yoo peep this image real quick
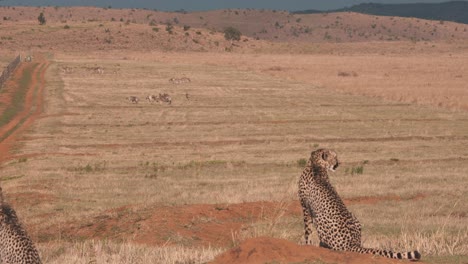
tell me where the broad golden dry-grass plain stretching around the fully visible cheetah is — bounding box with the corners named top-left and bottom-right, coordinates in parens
top-left (1, 48), bottom-right (468, 263)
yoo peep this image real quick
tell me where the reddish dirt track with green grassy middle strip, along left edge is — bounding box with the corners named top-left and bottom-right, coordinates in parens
top-left (0, 55), bottom-right (49, 164)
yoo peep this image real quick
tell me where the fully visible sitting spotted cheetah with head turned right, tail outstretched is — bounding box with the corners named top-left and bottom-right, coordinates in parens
top-left (299, 149), bottom-right (421, 260)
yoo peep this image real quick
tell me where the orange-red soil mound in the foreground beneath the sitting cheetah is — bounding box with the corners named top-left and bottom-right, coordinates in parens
top-left (211, 237), bottom-right (422, 264)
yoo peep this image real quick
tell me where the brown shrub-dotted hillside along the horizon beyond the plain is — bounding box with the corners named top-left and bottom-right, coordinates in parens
top-left (0, 7), bottom-right (468, 43)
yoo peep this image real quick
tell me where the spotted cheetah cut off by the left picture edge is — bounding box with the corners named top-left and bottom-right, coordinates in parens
top-left (0, 188), bottom-right (41, 264)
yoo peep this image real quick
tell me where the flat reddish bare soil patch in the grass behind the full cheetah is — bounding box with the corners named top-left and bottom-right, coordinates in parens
top-left (49, 194), bottom-right (426, 247)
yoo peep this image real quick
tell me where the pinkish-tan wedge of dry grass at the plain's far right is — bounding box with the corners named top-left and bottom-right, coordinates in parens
top-left (123, 47), bottom-right (468, 110)
